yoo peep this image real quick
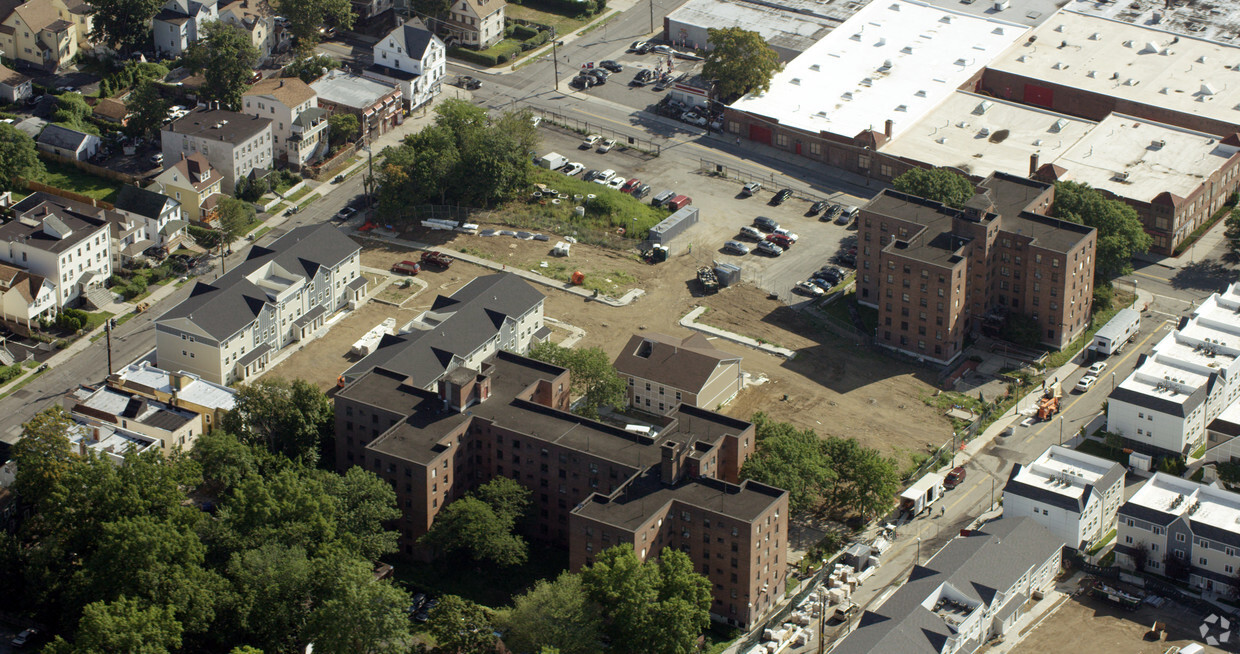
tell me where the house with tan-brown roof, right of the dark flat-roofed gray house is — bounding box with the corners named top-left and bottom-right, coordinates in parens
top-left (241, 77), bottom-right (327, 168)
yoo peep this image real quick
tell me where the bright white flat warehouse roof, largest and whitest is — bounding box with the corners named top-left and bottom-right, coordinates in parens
top-left (733, 0), bottom-right (1029, 138)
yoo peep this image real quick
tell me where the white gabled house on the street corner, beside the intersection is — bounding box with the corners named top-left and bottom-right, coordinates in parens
top-left (363, 19), bottom-right (448, 109)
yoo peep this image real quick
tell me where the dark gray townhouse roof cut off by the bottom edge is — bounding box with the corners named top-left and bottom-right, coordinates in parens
top-left (833, 517), bottom-right (1064, 654)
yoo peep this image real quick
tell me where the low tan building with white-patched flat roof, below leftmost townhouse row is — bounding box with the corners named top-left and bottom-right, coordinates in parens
top-left (107, 361), bottom-right (237, 432)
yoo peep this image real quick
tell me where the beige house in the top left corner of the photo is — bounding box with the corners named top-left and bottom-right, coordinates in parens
top-left (0, 0), bottom-right (78, 72)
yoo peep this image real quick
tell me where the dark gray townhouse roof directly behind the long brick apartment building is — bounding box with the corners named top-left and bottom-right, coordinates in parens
top-left (345, 273), bottom-right (543, 388)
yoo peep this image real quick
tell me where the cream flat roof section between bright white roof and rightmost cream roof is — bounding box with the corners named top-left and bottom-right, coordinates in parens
top-left (882, 91), bottom-right (1096, 177)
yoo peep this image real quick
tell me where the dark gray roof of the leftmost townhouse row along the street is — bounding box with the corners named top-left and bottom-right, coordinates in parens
top-left (159, 223), bottom-right (361, 340)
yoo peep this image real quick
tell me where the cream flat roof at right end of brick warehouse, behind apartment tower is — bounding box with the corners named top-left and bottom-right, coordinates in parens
top-left (1054, 114), bottom-right (1240, 202)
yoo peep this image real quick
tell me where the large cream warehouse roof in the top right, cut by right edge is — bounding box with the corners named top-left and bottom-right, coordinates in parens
top-left (988, 11), bottom-right (1240, 132)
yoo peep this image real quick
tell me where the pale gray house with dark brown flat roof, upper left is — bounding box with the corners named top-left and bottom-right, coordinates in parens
top-left (160, 109), bottom-right (274, 195)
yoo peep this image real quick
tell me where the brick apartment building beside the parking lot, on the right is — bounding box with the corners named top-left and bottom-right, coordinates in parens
top-left (857, 172), bottom-right (1097, 362)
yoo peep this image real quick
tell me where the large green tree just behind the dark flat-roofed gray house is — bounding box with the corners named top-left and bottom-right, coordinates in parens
top-left (185, 21), bottom-right (257, 109)
